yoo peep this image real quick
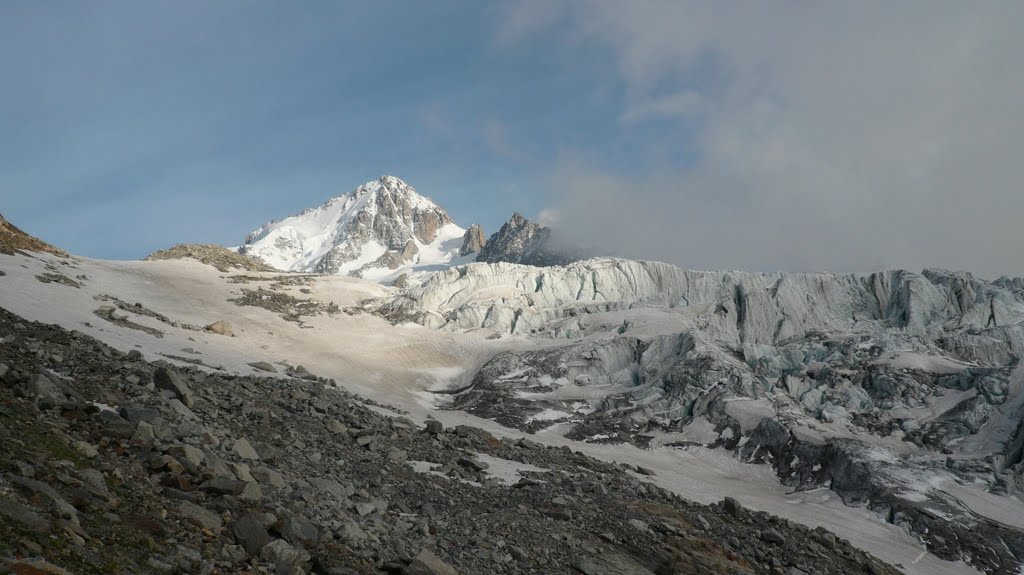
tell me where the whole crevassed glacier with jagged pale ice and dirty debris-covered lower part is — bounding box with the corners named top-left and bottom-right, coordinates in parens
top-left (370, 259), bottom-right (1024, 573)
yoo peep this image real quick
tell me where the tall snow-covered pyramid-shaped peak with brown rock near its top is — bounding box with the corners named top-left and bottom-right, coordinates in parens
top-left (239, 176), bottom-right (465, 279)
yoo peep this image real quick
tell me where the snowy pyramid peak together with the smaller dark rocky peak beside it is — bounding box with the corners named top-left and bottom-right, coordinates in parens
top-left (232, 176), bottom-right (595, 283)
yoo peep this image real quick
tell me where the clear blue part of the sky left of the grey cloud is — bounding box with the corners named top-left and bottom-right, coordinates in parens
top-left (0, 2), bottom-right (656, 258)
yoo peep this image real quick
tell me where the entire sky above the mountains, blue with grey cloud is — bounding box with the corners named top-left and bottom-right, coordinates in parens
top-left (0, 0), bottom-right (1024, 277)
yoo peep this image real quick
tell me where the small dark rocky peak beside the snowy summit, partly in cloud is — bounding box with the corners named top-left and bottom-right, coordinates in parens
top-left (476, 212), bottom-right (589, 266)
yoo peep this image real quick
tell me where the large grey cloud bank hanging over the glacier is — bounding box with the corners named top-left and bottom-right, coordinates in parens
top-left (504, 1), bottom-right (1024, 275)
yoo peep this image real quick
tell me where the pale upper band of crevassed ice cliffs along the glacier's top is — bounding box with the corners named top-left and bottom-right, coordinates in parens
top-left (379, 258), bottom-right (1024, 349)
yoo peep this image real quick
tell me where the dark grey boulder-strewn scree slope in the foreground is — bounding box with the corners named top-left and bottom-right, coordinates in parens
top-left (0, 309), bottom-right (897, 575)
